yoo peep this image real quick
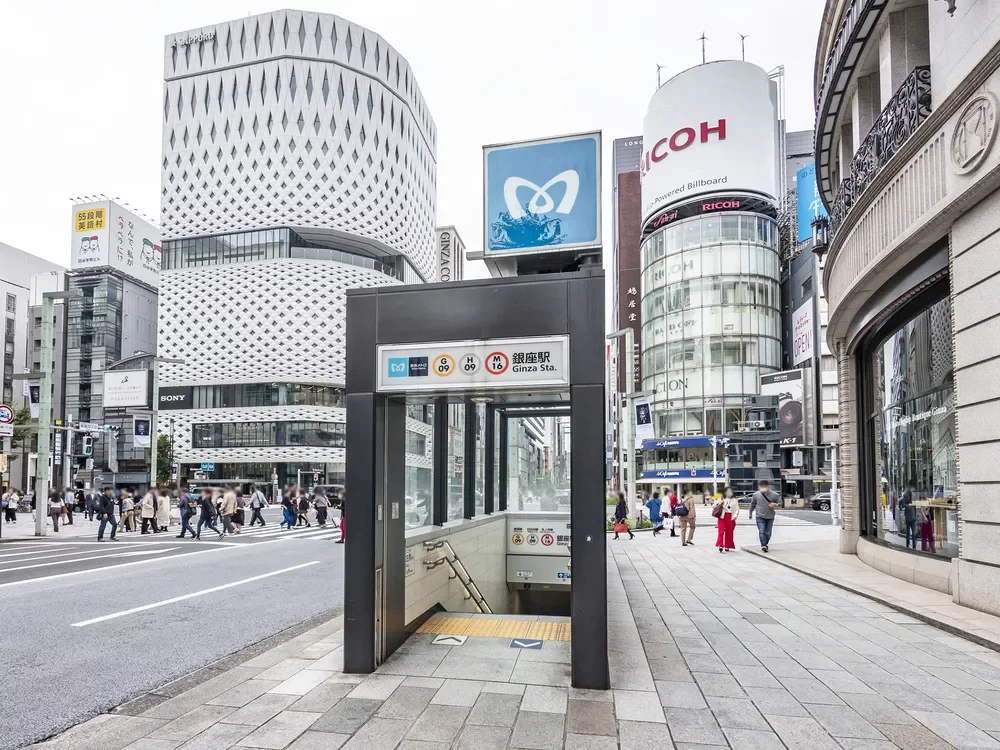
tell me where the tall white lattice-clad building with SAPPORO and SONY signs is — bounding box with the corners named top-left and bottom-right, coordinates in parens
top-left (159, 10), bottom-right (437, 494)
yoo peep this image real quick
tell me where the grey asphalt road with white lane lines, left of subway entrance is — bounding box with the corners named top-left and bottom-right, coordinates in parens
top-left (0, 511), bottom-right (344, 750)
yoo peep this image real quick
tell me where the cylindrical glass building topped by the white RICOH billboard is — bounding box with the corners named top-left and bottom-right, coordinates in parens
top-left (641, 61), bottom-right (781, 490)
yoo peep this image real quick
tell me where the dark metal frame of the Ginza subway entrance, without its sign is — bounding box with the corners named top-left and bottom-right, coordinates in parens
top-left (344, 268), bottom-right (610, 690)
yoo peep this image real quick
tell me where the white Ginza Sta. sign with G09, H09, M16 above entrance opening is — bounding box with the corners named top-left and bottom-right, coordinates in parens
top-left (376, 336), bottom-right (569, 393)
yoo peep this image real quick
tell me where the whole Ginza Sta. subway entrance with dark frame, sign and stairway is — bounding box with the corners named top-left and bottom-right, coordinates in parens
top-left (344, 269), bottom-right (610, 689)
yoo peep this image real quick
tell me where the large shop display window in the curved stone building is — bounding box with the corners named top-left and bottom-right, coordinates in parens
top-left (859, 288), bottom-right (958, 557)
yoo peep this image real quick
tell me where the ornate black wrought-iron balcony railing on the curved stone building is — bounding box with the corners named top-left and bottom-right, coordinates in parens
top-left (830, 65), bottom-right (931, 237)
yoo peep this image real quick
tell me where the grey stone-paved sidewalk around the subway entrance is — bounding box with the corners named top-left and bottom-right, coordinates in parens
top-left (31, 535), bottom-right (1000, 750)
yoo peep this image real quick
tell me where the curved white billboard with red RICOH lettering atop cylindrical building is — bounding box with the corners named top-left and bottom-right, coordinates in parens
top-left (640, 60), bottom-right (778, 222)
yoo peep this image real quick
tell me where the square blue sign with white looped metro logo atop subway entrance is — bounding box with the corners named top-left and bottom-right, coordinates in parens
top-left (483, 131), bottom-right (601, 257)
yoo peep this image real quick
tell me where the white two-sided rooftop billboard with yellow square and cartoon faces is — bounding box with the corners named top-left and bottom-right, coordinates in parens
top-left (70, 201), bottom-right (160, 289)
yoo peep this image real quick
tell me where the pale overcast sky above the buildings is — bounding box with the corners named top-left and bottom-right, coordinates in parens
top-left (0, 0), bottom-right (823, 274)
